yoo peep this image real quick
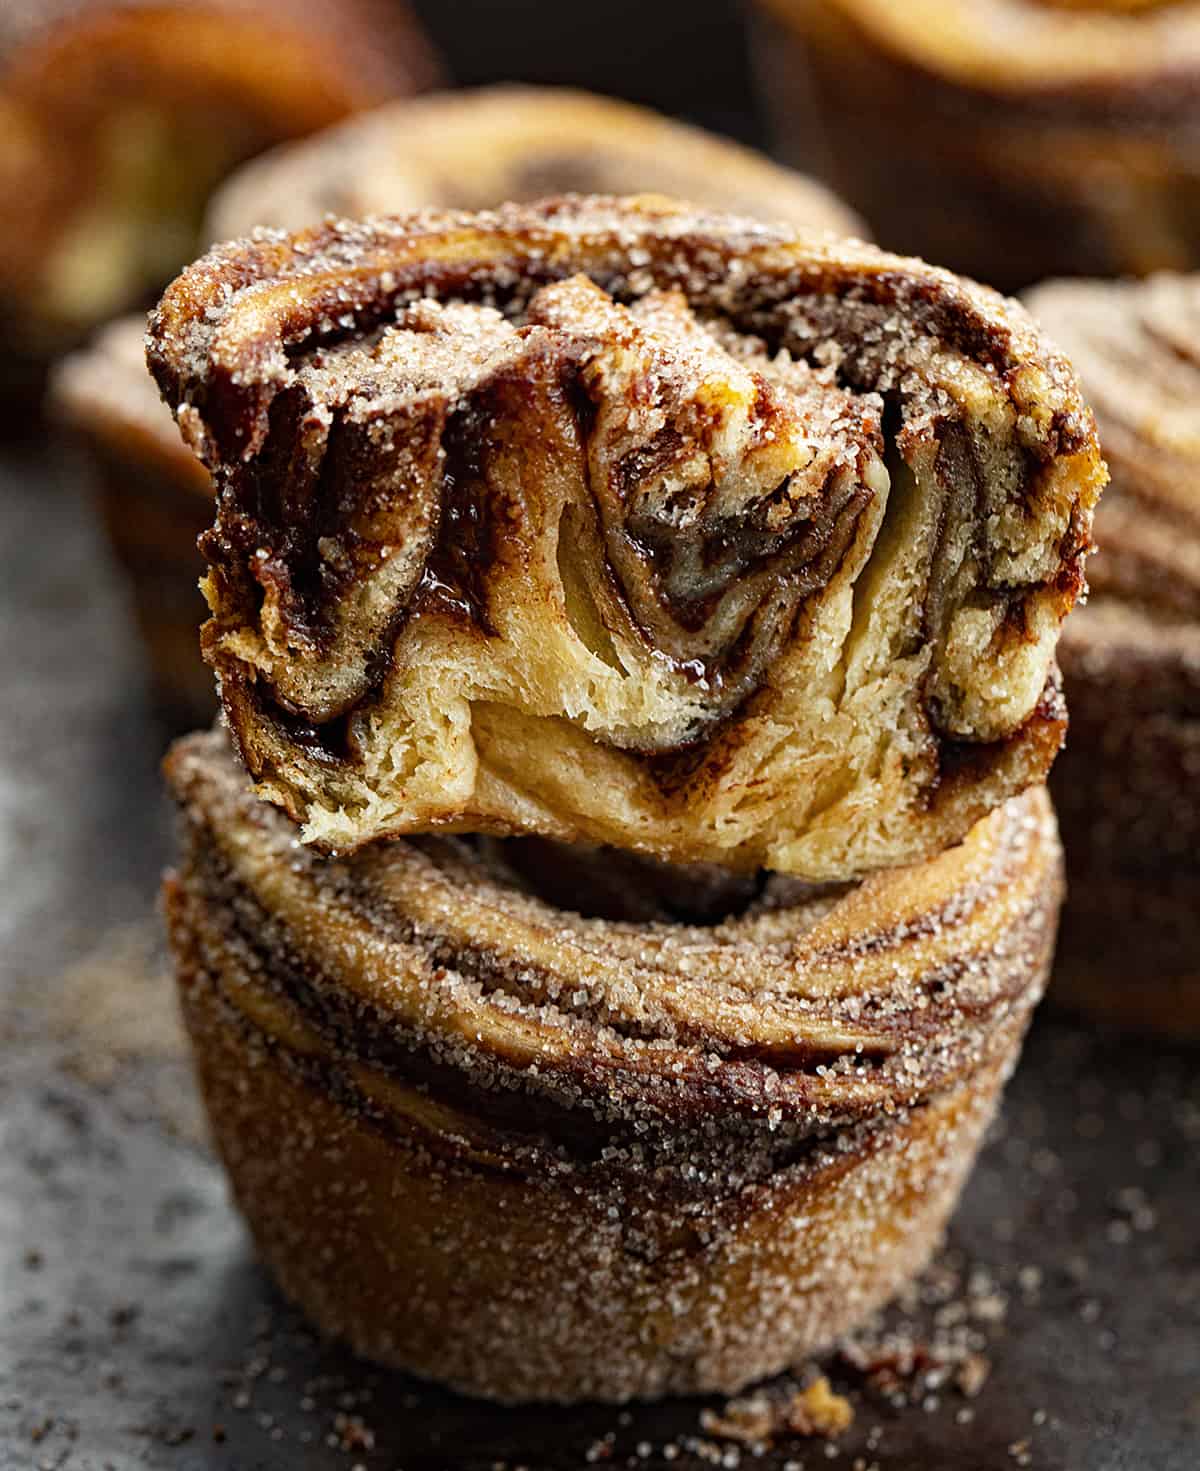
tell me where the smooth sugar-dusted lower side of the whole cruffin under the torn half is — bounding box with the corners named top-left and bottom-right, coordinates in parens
top-left (168, 890), bottom-right (1019, 1403)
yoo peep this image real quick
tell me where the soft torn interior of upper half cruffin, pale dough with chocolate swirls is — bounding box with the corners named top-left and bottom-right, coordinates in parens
top-left (198, 278), bottom-right (1066, 874)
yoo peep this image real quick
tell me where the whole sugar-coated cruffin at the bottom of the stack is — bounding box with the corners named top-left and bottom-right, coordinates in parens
top-left (166, 734), bottom-right (1060, 1400)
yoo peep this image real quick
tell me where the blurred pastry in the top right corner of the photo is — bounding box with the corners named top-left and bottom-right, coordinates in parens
top-left (756, 0), bottom-right (1200, 290)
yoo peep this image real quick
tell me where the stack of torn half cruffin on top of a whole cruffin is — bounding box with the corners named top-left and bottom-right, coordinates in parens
top-left (149, 197), bottom-right (1104, 1400)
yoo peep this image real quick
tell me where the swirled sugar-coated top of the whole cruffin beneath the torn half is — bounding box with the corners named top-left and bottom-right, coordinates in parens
top-left (166, 731), bottom-right (1060, 1169)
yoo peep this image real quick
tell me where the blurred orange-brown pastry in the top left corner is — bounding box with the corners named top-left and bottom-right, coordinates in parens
top-left (0, 0), bottom-right (435, 380)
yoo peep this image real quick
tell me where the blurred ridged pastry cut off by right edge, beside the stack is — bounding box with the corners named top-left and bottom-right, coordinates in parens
top-left (1028, 275), bottom-right (1200, 1039)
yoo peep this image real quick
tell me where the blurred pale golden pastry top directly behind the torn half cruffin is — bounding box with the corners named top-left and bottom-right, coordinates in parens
top-left (207, 85), bottom-right (866, 240)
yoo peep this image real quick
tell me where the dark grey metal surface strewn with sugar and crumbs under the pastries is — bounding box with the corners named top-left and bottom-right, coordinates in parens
top-left (0, 455), bottom-right (1200, 1471)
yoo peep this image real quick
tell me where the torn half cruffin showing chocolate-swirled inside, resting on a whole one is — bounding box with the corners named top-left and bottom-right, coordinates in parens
top-left (150, 199), bottom-right (1103, 880)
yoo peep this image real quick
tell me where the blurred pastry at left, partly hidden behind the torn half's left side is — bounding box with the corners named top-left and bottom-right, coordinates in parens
top-left (50, 313), bottom-right (215, 730)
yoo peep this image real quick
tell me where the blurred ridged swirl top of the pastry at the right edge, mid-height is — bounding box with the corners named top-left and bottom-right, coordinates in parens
top-left (1028, 275), bottom-right (1200, 634)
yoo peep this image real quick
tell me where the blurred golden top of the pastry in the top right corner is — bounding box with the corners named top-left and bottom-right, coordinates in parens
top-left (760, 0), bottom-right (1200, 89)
